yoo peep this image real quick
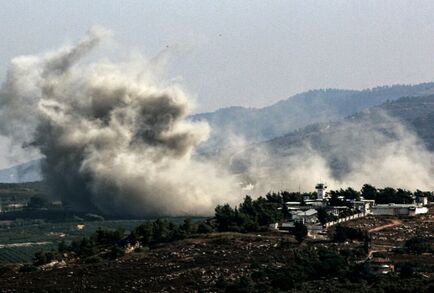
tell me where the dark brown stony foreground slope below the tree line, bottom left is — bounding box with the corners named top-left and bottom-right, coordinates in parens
top-left (0, 234), bottom-right (304, 292)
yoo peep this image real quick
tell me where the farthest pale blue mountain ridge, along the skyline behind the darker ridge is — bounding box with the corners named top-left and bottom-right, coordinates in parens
top-left (191, 83), bottom-right (434, 152)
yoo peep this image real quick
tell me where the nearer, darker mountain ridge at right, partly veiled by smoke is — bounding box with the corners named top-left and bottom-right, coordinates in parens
top-left (231, 95), bottom-right (434, 178)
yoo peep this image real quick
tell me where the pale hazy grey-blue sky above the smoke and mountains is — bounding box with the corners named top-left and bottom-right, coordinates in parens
top-left (0, 0), bottom-right (434, 111)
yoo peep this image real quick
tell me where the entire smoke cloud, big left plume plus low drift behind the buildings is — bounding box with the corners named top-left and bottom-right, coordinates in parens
top-left (0, 28), bottom-right (434, 216)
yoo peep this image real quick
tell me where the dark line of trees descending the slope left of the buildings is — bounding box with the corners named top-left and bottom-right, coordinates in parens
top-left (34, 193), bottom-right (307, 265)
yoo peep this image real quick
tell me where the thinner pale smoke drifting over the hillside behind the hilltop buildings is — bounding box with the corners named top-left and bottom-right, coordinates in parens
top-left (232, 111), bottom-right (434, 194)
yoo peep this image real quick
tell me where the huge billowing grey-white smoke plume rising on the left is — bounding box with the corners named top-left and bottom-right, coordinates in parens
top-left (0, 29), bottom-right (240, 216)
